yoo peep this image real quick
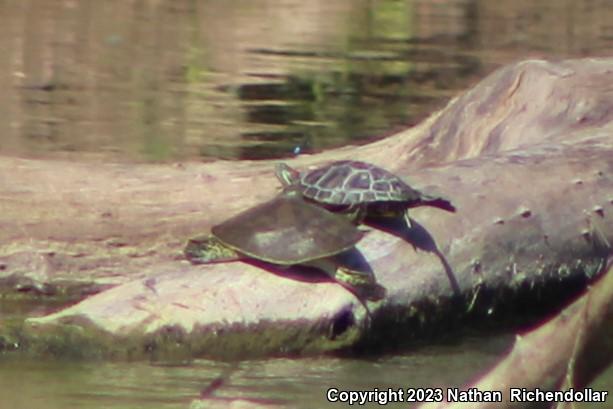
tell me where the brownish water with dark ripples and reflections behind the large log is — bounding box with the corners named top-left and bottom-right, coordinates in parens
top-left (0, 0), bottom-right (613, 160)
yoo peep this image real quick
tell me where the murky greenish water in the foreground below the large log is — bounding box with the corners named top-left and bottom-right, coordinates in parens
top-left (0, 337), bottom-right (511, 409)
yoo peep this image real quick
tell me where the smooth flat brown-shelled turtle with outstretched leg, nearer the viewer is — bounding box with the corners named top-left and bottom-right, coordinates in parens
top-left (183, 189), bottom-right (385, 300)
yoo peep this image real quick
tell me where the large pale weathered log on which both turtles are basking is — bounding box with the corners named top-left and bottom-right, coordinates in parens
top-left (0, 59), bottom-right (613, 357)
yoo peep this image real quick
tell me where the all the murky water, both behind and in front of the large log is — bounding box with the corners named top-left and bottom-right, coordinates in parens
top-left (0, 0), bottom-right (613, 408)
